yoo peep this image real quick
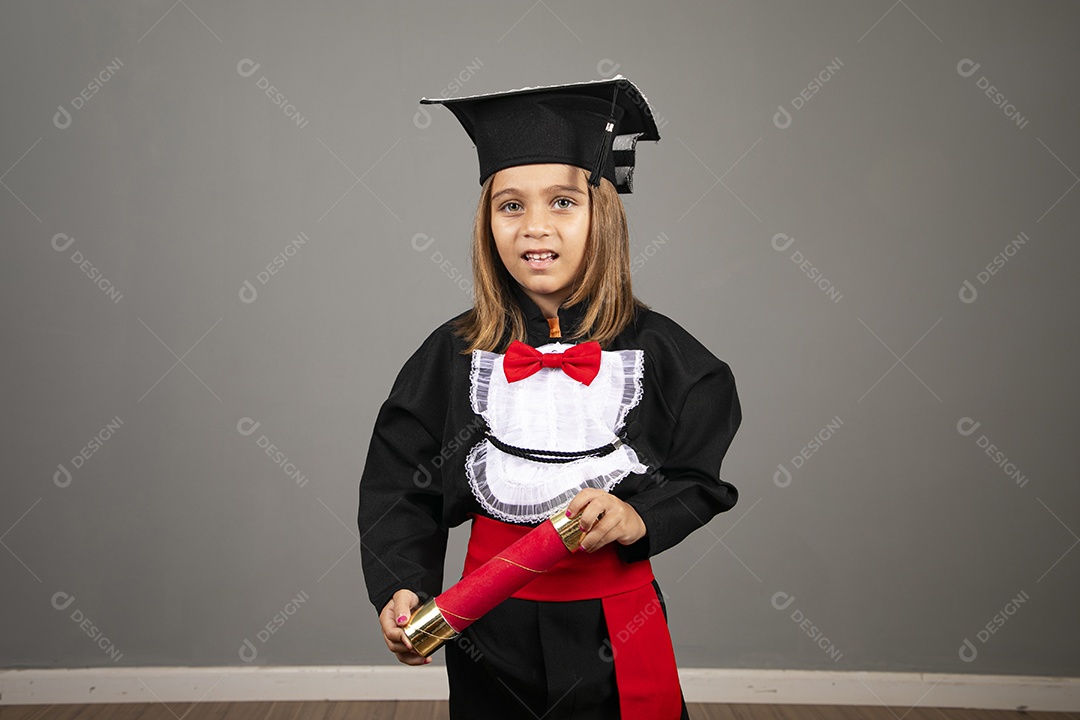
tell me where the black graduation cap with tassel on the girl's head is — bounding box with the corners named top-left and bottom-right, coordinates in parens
top-left (420, 74), bottom-right (660, 192)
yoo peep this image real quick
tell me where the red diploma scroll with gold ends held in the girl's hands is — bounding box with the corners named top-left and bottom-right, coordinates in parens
top-left (404, 505), bottom-right (584, 657)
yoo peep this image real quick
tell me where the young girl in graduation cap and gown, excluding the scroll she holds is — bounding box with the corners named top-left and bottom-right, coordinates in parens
top-left (359, 76), bottom-right (741, 720)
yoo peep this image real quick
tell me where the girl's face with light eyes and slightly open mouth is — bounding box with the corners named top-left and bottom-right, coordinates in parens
top-left (490, 164), bottom-right (591, 317)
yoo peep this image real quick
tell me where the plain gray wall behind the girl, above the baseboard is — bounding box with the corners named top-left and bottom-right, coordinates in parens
top-left (0, 0), bottom-right (1080, 676)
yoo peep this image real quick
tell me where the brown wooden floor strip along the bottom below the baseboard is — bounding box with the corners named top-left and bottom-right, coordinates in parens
top-left (0, 702), bottom-right (1080, 720)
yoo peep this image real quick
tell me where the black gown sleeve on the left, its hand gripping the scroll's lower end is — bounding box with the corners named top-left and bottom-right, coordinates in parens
top-left (357, 326), bottom-right (454, 611)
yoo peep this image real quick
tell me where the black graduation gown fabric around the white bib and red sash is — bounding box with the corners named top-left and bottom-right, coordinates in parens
top-left (357, 287), bottom-right (742, 718)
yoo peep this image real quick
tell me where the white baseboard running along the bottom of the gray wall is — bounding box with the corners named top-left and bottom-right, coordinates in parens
top-left (0, 664), bottom-right (1080, 712)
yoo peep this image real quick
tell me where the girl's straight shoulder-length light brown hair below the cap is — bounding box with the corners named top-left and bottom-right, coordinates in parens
top-left (455, 166), bottom-right (647, 354)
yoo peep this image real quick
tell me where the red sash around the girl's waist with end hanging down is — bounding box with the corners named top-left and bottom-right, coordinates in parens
top-left (461, 513), bottom-right (683, 720)
